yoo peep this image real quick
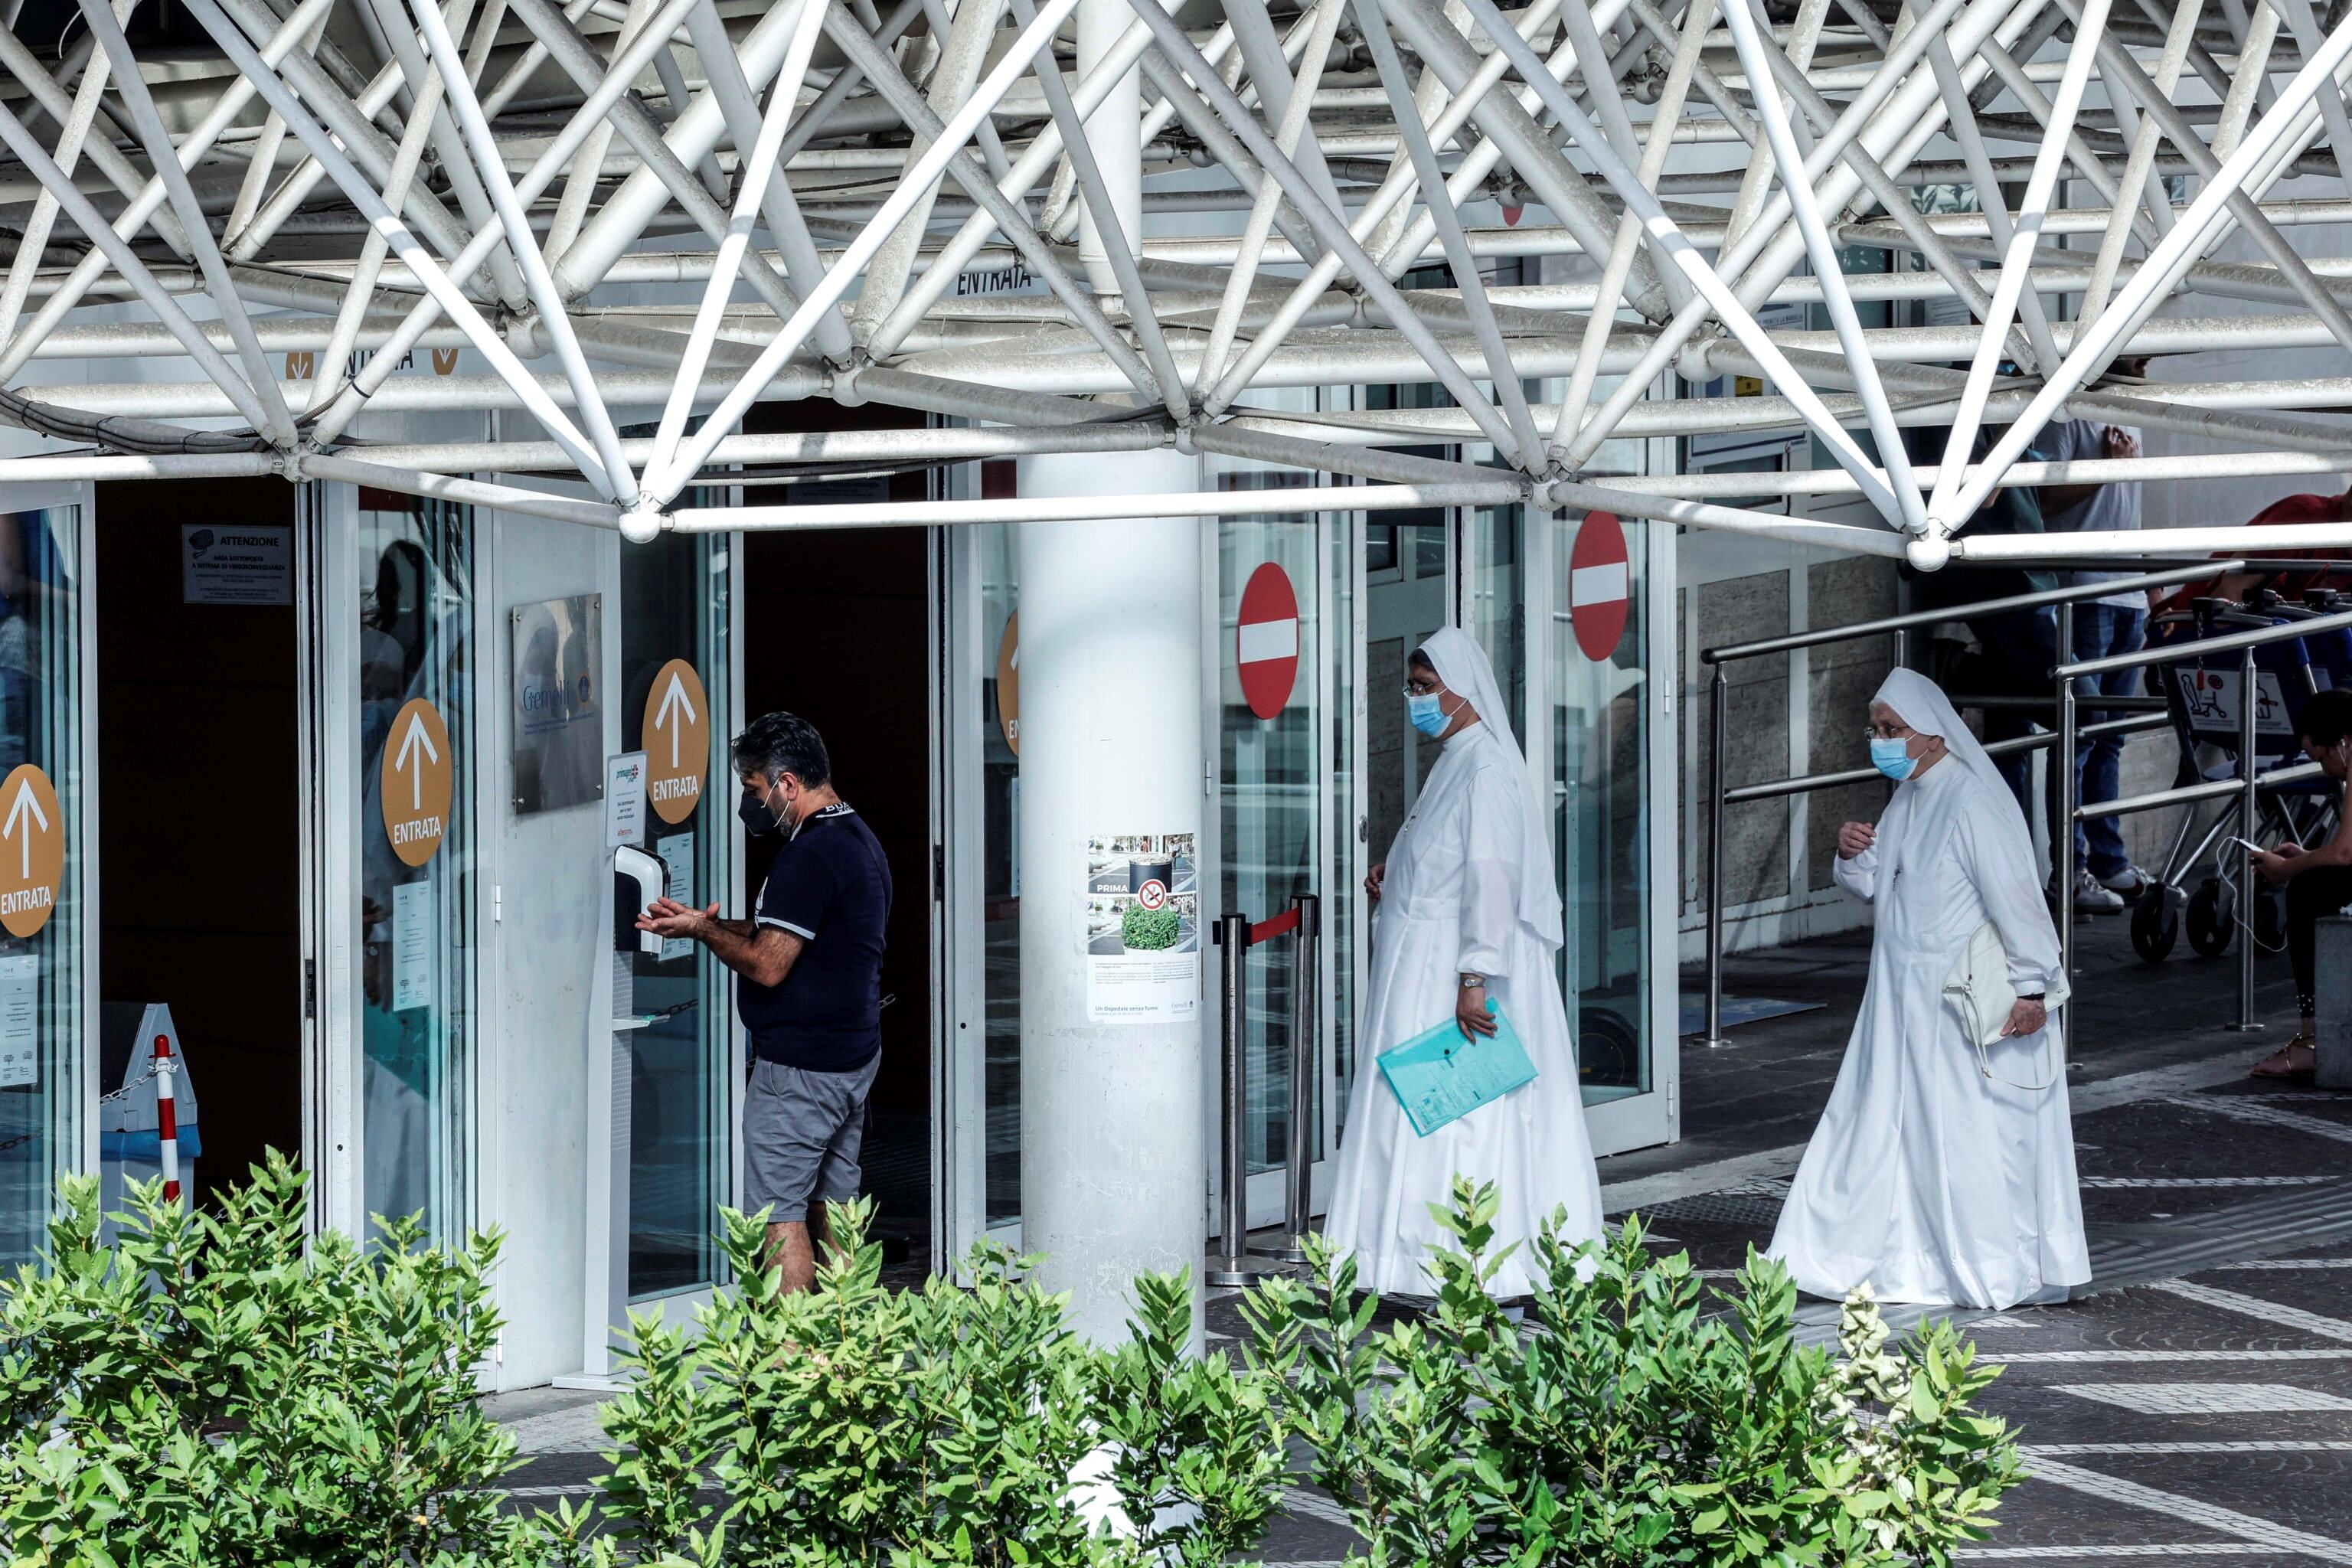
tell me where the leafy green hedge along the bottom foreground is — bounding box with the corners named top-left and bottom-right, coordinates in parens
top-left (0, 1159), bottom-right (2018, 1568)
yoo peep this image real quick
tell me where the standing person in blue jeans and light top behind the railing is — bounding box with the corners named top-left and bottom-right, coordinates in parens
top-left (2034, 355), bottom-right (2150, 914)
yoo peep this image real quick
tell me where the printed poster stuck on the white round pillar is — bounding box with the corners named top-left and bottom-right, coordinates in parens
top-left (1084, 832), bottom-right (1200, 1023)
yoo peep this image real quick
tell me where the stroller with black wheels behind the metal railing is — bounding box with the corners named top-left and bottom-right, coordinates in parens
top-left (2131, 588), bottom-right (2352, 964)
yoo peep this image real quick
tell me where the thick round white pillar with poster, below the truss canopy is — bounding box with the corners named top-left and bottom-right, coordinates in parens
top-left (1018, 452), bottom-right (1216, 1342)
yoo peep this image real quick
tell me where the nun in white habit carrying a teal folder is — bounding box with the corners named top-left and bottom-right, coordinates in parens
top-left (1325, 628), bottom-right (1602, 1298)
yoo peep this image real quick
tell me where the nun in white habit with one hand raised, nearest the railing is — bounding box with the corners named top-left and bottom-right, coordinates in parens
top-left (1771, 670), bottom-right (2091, 1307)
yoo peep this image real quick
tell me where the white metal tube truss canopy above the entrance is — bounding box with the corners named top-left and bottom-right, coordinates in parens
top-left (0, 0), bottom-right (2352, 569)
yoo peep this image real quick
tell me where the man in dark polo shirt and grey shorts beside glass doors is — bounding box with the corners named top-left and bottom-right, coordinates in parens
top-left (638, 712), bottom-right (891, 1291)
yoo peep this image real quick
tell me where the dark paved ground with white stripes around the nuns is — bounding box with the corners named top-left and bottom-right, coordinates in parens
top-left (494, 920), bottom-right (2352, 1568)
